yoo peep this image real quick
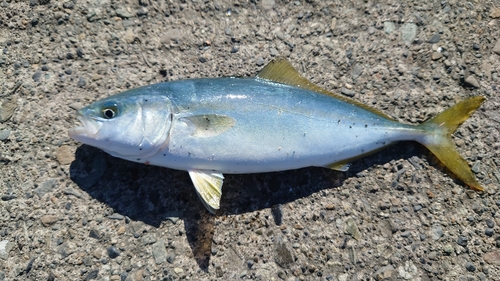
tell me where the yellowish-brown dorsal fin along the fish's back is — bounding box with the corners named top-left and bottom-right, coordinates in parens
top-left (257, 58), bottom-right (394, 120)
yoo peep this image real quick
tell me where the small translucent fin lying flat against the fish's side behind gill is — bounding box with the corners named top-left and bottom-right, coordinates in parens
top-left (183, 114), bottom-right (236, 138)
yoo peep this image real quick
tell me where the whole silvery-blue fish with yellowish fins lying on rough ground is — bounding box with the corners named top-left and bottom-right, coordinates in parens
top-left (69, 58), bottom-right (485, 214)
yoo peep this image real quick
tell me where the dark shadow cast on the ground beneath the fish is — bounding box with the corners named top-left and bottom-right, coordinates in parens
top-left (70, 142), bottom-right (422, 272)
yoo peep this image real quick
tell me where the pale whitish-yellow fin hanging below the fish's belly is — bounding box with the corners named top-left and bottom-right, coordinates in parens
top-left (189, 170), bottom-right (224, 214)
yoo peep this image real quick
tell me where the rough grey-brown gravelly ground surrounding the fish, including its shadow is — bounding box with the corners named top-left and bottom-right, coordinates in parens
top-left (0, 0), bottom-right (500, 281)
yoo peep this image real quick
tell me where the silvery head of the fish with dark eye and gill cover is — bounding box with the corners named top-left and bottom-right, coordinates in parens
top-left (69, 90), bottom-right (173, 161)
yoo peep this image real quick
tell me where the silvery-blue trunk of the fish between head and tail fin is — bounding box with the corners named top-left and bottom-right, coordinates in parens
top-left (113, 78), bottom-right (418, 173)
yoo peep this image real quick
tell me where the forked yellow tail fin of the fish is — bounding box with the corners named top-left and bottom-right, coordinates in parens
top-left (420, 96), bottom-right (485, 191)
